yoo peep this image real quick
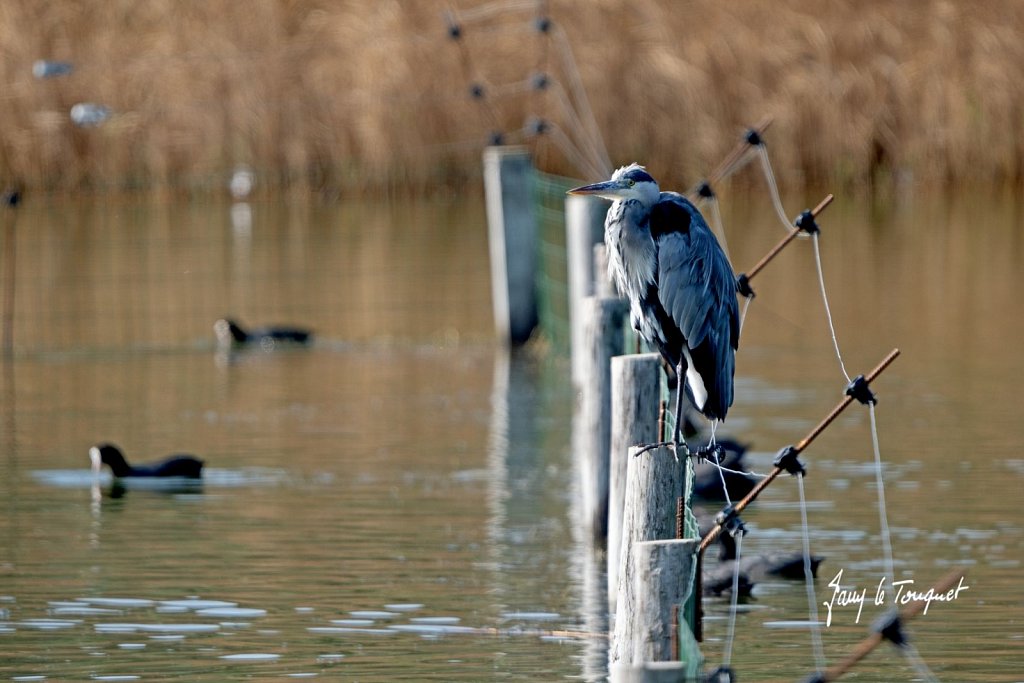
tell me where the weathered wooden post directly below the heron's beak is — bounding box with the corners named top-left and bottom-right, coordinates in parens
top-left (565, 195), bottom-right (608, 386)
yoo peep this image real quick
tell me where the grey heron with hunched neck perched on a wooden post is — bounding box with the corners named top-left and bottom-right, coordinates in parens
top-left (569, 164), bottom-right (739, 449)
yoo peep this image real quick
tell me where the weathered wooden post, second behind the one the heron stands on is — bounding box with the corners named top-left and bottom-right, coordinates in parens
top-left (579, 297), bottom-right (627, 542)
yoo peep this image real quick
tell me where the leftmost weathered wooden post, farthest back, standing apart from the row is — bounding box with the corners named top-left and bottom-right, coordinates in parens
top-left (483, 146), bottom-right (538, 344)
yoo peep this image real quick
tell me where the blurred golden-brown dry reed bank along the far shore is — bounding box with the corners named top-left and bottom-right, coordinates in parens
top-left (0, 0), bottom-right (1024, 191)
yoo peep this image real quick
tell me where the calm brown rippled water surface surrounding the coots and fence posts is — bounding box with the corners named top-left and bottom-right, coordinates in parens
top-left (0, 189), bottom-right (1024, 681)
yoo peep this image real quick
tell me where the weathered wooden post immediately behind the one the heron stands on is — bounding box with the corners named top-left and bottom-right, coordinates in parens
top-left (607, 353), bottom-right (662, 610)
